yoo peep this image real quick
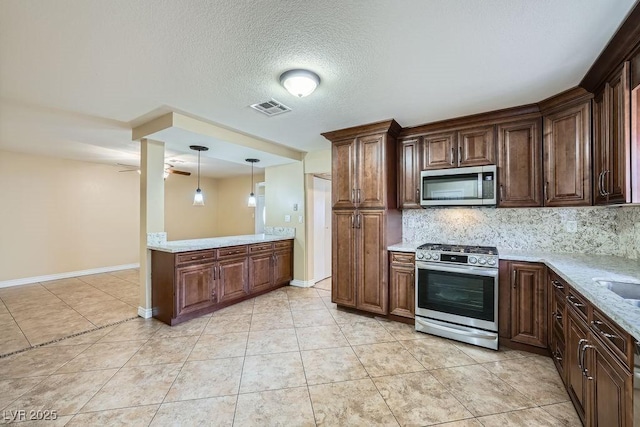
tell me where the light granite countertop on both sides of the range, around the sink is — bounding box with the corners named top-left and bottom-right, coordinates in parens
top-left (387, 243), bottom-right (640, 339)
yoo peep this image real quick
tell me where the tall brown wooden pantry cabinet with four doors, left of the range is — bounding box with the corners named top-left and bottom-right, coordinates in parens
top-left (322, 120), bottom-right (402, 314)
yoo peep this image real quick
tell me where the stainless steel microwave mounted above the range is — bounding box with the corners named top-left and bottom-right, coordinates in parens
top-left (420, 165), bottom-right (497, 207)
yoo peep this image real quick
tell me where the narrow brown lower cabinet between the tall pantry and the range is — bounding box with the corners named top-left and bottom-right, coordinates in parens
top-left (389, 252), bottom-right (416, 319)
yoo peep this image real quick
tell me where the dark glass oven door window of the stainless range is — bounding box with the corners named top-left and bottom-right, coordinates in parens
top-left (417, 269), bottom-right (496, 322)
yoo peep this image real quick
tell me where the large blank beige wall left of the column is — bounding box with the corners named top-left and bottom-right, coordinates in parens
top-left (0, 151), bottom-right (139, 281)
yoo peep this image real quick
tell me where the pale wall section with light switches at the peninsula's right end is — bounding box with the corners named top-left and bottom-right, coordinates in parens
top-left (265, 162), bottom-right (312, 281)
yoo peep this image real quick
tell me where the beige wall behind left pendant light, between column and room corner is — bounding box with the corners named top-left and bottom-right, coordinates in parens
top-left (164, 175), bottom-right (221, 240)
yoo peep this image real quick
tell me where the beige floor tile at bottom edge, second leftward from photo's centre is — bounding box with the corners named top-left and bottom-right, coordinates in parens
top-left (151, 396), bottom-right (236, 427)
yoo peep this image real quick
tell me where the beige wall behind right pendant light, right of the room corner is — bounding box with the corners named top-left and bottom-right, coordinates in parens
top-left (216, 174), bottom-right (264, 236)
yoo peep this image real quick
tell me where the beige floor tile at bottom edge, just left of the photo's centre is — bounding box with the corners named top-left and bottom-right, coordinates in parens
top-left (234, 387), bottom-right (316, 427)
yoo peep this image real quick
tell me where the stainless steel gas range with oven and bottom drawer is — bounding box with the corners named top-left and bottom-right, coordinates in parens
top-left (416, 243), bottom-right (498, 350)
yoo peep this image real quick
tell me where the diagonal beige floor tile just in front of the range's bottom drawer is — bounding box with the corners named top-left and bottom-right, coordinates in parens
top-left (400, 338), bottom-right (477, 369)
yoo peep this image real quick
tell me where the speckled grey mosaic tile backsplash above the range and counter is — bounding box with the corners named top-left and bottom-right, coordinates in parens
top-left (402, 205), bottom-right (640, 259)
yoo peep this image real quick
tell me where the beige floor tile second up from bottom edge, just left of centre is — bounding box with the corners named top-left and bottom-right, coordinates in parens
top-left (240, 351), bottom-right (307, 393)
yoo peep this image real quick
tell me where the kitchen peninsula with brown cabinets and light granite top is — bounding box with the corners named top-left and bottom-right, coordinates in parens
top-left (148, 234), bottom-right (293, 326)
